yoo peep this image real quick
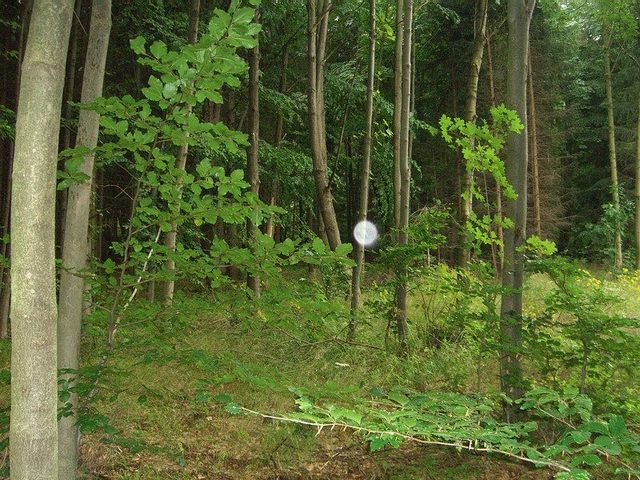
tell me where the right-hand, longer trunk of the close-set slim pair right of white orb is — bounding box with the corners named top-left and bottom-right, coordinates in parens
top-left (396, 0), bottom-right (413, 355)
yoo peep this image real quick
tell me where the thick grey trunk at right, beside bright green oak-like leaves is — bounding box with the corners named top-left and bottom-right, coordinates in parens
top-left (500, 0), bottom-right (535, 420)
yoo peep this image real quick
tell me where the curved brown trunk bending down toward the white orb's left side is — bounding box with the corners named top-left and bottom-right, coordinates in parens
top-left (307, 0), bottom-right (342, 250)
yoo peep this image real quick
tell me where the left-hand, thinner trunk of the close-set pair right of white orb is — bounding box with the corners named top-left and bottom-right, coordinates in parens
top-left (392, 0), bottom-right (404, 234)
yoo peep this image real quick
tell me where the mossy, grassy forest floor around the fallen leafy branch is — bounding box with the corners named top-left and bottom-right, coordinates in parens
top-left (0, 268), bottom-right (638, 480)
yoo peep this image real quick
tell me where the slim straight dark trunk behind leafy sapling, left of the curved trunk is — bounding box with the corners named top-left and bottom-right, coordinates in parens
top-left (247, 10), bottom-right (260, 297)
